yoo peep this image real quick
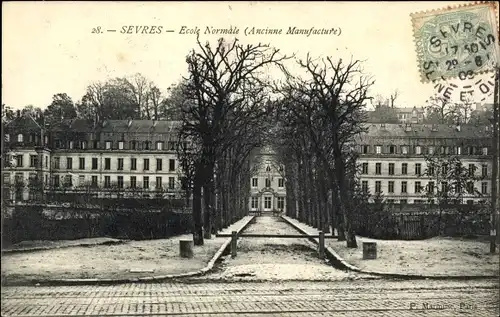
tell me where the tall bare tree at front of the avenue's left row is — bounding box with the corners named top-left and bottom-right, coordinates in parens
top-left (180, 39), bottom-right (286, 245)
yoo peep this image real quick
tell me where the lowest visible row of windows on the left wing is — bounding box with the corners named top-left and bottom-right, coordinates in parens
top-left (53, 175), bottom-right (180, 189)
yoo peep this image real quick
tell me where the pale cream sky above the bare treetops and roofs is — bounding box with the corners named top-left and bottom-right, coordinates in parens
top-left (2, 1), bottom-right (498, 109)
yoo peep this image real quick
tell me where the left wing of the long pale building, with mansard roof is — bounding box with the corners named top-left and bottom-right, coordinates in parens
top-left (2, 116), bottom-right (188, 201)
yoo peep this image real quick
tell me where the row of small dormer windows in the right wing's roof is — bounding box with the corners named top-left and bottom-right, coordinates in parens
top-left (361, 145), bottom-right (488, 155)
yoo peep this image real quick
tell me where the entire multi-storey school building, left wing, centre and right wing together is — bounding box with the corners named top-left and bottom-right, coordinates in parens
top-left (2, 112), bottom-right (492, 211)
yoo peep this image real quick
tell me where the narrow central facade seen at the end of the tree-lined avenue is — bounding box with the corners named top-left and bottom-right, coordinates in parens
top-left (249, 147), bottom-right (286, 212)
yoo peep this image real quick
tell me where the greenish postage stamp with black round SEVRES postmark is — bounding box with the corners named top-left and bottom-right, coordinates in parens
top-left (411, 2), bottom-right (500, 82)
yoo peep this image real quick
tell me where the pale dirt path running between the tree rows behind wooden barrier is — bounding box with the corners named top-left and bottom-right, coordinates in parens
top-left (207, 215), bottom-right (376, 280)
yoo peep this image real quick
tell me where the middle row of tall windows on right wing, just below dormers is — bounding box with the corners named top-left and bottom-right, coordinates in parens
top-left (361, 162), bottom-right (488, 177)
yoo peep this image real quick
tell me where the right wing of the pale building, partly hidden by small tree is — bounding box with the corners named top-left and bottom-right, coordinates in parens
top-left (356, 123), bottom-right (492, 204)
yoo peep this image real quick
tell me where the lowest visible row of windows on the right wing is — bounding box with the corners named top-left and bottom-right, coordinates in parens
top-left (361, 181), bottom-right (488, 195)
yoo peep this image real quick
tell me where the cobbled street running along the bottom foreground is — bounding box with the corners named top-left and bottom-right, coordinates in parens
top-left (1, 280), bottom-right (499, 317)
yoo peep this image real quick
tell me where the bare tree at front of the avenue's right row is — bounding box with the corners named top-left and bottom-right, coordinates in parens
top-left (282, 55), bottom-right (373, 248)
